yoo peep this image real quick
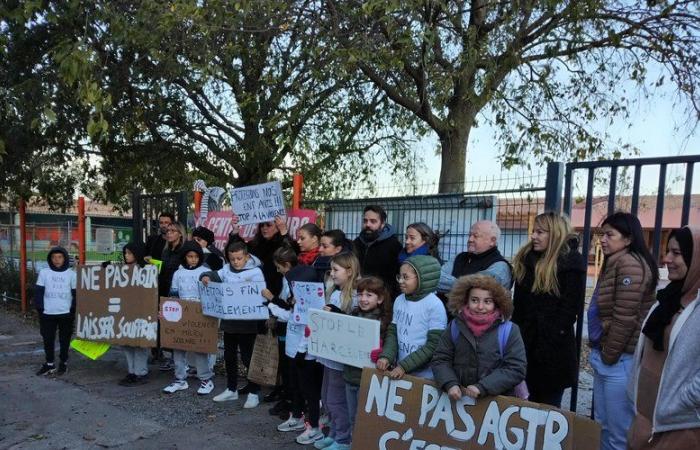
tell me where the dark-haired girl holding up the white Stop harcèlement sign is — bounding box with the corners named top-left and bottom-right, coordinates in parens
top-left (343, 277), bottom-right (391, 438)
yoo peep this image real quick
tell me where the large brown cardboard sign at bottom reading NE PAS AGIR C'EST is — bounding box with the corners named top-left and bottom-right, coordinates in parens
top-left (352, 369), bottom-right (600, 450)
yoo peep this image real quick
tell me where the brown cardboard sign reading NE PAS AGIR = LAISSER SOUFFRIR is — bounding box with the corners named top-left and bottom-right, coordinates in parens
top-left (75, 264), bottom-right (158, 348)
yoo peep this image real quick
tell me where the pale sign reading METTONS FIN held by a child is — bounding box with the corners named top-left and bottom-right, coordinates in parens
top-left (199, 281), bottom-right (270, 320)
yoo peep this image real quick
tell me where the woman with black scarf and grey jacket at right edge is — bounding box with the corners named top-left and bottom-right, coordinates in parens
top-left (628, 227), bottom-right (700, 450)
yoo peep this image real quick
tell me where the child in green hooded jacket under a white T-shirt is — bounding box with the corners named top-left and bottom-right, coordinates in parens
top-left (377, 255), bottom-right (447, 380)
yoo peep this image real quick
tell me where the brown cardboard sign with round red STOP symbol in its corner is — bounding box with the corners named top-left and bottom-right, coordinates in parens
top-left (160, 297), bottom-right (219, 353)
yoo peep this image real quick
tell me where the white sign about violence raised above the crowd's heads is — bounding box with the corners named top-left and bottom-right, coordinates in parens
top-left (229, 181), bottom-right (286, 225)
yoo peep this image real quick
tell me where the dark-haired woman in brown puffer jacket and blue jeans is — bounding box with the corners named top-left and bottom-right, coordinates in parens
top-left (588, 212), bottom-right (659, 450)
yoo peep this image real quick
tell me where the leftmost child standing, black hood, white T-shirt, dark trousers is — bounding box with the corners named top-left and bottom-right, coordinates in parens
top-left (34, 247), bottom-right (76, 375)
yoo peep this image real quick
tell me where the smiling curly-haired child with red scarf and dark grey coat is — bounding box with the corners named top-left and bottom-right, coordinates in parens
top-left (432, 275), bottom-right (527, 400)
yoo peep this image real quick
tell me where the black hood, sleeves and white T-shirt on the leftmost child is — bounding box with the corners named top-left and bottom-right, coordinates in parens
top-left (34, 247), bottom-right (76, 315)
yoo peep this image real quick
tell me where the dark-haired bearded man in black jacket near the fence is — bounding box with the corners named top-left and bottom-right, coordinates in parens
top-left (353, 205), bottom-right (403, 297)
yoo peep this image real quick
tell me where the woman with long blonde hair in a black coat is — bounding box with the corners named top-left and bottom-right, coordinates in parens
top-left (513, 212), bottom-right (586, 407)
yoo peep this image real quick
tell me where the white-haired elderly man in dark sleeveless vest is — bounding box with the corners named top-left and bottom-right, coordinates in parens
top-left (438, 220), bottom-right (513, 292)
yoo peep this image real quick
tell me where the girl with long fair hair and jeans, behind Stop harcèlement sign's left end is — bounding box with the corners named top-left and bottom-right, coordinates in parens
top-left (314, 253), bottom-right (360, 450)
